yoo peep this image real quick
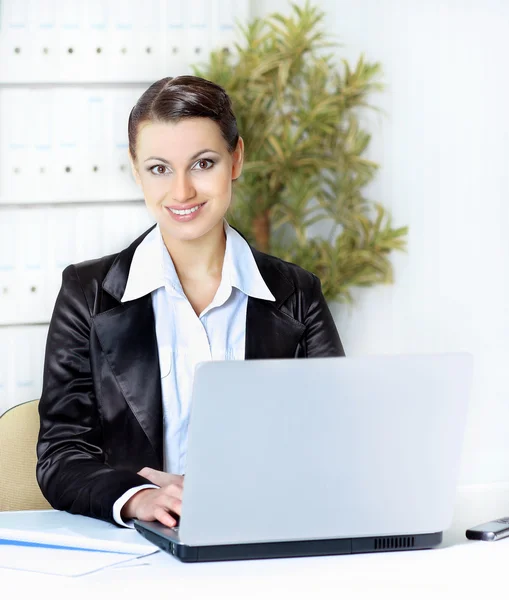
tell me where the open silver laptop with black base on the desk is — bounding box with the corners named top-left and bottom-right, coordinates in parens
top-left (134, 353), bottom-right (473, 562)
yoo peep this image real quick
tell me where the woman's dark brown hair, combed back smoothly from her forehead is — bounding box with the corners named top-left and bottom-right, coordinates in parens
top-left (127, 75), bottom-right (239, 159)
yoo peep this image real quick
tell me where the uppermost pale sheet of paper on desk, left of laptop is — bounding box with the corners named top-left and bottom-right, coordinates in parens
top-left (0, 510), bottom-right (157, 556)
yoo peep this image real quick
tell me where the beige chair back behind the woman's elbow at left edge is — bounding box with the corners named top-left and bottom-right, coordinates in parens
top-left (0, 400), bottom-right (51, 511)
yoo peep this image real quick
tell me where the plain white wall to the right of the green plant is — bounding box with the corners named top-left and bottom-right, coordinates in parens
top-left (253, 0), bottom-right (509, 484)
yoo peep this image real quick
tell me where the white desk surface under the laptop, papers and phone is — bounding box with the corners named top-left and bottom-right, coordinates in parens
top-left (0, 484), bottom-right (509, 600)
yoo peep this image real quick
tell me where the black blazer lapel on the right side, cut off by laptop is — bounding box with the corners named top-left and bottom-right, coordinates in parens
top-left (245, 248), bottom-right (305, 359)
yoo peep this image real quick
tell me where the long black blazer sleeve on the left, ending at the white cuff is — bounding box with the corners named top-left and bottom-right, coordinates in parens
top-left (37, 265), bottom-right (150, 522)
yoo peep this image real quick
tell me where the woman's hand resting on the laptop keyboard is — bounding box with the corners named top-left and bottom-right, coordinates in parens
top-left (121, 467), bottom-right (184, 527)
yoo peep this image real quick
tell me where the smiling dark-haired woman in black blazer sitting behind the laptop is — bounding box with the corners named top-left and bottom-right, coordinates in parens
top-left (37, 76), bottom-right (344, 527)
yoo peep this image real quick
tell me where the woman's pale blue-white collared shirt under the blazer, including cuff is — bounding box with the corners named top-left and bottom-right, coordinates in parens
top-left (113, 221), bottom-right (275, 525)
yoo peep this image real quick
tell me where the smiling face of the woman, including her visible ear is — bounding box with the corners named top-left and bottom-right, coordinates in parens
top-left (132, 118), bottom-right (244, 241)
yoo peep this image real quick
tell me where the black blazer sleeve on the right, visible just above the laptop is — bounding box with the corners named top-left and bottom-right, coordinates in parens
top-left (304, 275), bottom-right (345, 358)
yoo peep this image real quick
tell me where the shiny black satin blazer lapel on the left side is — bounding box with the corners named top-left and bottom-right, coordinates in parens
top-left (93, 224), bottom-right (163, 469)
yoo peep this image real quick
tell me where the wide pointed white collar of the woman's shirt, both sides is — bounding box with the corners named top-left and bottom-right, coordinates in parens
top-left (121, 220), bottom-right (275, 302)
